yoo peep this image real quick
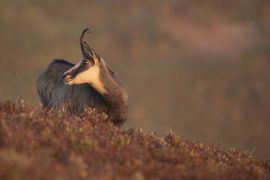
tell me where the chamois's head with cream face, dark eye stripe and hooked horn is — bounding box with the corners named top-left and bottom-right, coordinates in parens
top-left (63, 28), bottom-right (104, 91)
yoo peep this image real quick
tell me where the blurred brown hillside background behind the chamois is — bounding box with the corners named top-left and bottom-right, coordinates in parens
top-left (0, 0), bottom-right (270, 160)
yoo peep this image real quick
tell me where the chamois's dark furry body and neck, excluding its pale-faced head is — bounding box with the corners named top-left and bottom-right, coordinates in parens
top-left (37, 59), bottom-right (128, 125)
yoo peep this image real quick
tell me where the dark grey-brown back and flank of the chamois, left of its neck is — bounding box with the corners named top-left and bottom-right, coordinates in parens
top-left (37, 59), bottom-right (107, 113)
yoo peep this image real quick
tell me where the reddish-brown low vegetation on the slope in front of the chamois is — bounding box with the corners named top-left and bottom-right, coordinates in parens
top-left (0, 101), bottom-right (270, 179)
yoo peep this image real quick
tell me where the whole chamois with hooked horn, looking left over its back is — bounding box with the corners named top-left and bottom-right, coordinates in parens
top-left (36, 28), bottom-right (128, 126)
